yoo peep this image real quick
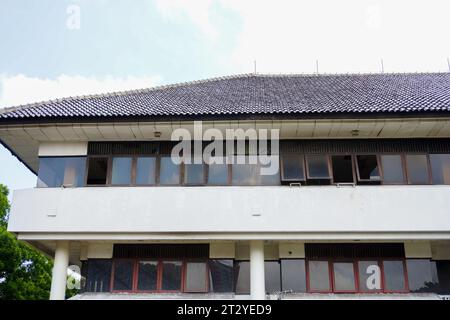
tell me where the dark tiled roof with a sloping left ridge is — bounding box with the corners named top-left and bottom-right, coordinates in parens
top-left (0, 73), bottom-right (450, 122)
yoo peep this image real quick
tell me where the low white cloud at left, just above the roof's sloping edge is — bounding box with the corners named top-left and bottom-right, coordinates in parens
top-left (0, 74), bottom-right (161, 107)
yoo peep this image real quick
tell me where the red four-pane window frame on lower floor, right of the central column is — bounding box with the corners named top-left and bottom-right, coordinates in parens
top-left (305, 257), bottom-right (410, 294)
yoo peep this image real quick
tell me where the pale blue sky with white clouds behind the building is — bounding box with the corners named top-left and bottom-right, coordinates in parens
top-left (0, 0), bottom-right (450, 198)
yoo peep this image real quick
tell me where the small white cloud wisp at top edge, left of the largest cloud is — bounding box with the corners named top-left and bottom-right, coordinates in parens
top-left (155, 0), bottom-right (218, 40)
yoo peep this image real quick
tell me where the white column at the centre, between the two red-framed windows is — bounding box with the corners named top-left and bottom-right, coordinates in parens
top-left (250, 240), bottom-right (266, 300)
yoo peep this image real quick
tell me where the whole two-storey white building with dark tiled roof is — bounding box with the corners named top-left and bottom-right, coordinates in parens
top-left (0, 73), bottom-right (450, 299)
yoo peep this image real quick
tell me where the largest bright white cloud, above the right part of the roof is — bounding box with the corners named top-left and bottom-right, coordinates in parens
top-left (221, 0), bottom-right (450, 73)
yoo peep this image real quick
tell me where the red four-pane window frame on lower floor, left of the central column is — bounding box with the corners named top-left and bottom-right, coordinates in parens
top-left (110, 258), bottom-right (209, 293)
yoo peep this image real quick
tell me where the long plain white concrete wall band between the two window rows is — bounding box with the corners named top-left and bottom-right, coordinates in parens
top-left (9, 186), bottom-right (450, 233)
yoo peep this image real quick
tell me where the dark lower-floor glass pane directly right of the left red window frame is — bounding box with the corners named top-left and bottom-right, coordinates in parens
top-left (209, 260), bottom-right (233, 292)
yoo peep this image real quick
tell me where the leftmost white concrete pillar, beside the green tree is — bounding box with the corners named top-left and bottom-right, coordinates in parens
top-left (50, 241), bottom-right (69, 300)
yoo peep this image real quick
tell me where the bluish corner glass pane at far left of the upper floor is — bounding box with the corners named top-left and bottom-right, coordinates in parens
top-left (37, 157), bottom-right (86, 188)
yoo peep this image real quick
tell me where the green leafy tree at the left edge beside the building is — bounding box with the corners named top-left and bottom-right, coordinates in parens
top-left (0, 184), bottom-right (53, 300)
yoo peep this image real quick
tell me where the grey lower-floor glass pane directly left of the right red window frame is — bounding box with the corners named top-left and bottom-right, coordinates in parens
top-left (281, 259), bottom-right (306, 292)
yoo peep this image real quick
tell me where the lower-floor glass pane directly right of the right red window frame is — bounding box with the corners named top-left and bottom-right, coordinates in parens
top-left (406, 259), bottom-right (439, 292)
